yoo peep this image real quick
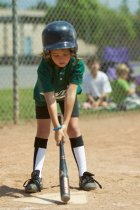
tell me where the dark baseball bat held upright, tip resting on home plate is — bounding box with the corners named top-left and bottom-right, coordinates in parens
top-left (58, 115), bottom-right (70, 203)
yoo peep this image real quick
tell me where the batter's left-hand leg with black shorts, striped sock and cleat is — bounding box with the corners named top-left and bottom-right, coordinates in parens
top-left (23, 106), bottom-right (50, 193)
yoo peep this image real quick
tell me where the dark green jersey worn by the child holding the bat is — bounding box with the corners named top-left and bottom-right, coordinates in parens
top-left (34, 58), bottom-right (84, 105)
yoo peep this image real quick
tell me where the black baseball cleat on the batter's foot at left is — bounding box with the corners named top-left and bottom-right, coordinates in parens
top-left (23, 170), bottom-right (43, 193)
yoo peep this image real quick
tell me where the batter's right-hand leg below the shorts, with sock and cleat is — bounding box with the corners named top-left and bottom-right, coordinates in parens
top-left (68, 118), bottom-right (102, 191)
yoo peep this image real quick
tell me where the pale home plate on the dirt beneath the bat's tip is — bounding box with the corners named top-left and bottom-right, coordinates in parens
top-left (14, 191), bottom-right (87, 205)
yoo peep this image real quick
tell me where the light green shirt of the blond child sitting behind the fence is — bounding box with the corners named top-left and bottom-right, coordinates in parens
top-left (112, 79), bottom-right (129, 104)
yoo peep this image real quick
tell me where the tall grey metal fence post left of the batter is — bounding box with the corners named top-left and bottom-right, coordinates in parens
top-left (12, 0), bottom-right (19, 124)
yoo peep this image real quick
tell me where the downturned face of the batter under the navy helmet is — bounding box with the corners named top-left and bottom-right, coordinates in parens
top-left (50, 49), bottom-right (71, 67)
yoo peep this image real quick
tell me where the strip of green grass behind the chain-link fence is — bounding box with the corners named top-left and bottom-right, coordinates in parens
top-left (0, 88), bottom-right (140, 123)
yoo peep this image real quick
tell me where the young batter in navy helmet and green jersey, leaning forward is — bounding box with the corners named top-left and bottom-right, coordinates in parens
top-left (23, 21), bottom-right (101, 193)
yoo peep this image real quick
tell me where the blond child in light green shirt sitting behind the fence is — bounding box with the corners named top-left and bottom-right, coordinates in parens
top-left (112, 63), bottom-right (140, 110)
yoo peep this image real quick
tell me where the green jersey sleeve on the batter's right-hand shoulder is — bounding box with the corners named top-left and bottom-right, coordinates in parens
top-left (70, 60), bottom-right (85, 85)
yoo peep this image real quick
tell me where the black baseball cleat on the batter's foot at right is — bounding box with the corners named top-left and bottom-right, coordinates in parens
top-left (79, 171), bottom-right (102, 191)
